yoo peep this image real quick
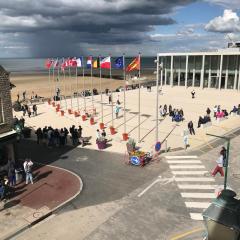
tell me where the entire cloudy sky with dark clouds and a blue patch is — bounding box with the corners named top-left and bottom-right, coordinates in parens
top-left (0, 0), bottom-right (240, 58)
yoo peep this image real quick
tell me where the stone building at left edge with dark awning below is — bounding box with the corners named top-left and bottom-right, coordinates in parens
top-left (0, 66), bottom-right (16, 166)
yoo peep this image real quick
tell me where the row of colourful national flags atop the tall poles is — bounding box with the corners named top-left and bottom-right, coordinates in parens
top-left (45, 56), bottom-right (140, 72)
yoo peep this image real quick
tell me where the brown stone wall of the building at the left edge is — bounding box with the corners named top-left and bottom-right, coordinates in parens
top-left (0, 66), bottom-right (13, 134)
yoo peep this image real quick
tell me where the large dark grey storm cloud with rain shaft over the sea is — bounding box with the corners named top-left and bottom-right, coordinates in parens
top-left (0, 0), bottom-right (195, 56)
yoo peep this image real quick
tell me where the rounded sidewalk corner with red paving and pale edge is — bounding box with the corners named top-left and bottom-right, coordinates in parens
top-left (0, 163), bottom-right (82, 239)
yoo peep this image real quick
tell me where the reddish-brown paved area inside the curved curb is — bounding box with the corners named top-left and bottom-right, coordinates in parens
top-left (12, 164), bottom-right (81, 210)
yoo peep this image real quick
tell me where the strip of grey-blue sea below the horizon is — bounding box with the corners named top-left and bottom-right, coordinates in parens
top-left (0, 57), bottom-right (156, 74)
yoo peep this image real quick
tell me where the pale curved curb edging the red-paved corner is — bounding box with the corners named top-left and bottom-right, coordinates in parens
top-left (4, 162), bottom-right (83, 240)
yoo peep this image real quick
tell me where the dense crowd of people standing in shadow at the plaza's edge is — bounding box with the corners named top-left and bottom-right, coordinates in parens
top-left (35, 125), bottom-right (84, 147)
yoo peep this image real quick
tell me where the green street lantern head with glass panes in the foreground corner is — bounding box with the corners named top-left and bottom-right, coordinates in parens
top-left (203, 189), bottom-right (240, 240)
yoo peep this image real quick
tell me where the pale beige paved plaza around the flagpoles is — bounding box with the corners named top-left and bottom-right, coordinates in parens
top-left (16, 87), bottom-right (240, 153)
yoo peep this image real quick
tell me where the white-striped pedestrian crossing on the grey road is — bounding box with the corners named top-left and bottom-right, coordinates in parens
top-left (165, 156), bottom-right (217, 221)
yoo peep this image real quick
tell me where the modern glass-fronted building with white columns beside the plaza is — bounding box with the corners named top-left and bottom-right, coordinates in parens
top-left (157, 48), bottom-right (240, 91)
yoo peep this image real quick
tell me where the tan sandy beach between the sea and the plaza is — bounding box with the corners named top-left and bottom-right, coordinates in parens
top-left (10, 74), bottom-right (124, 102)
